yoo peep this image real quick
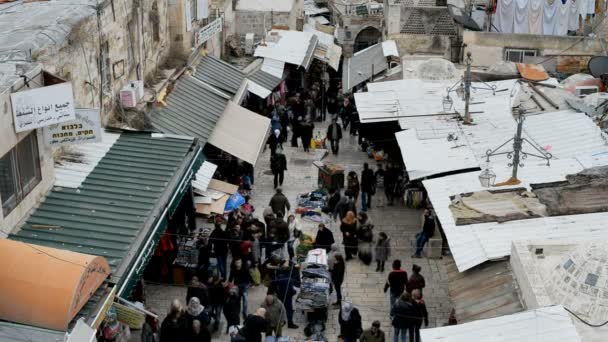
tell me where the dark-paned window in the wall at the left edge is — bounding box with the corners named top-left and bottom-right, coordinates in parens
top-left (0, 131), bottom-right (42, 217)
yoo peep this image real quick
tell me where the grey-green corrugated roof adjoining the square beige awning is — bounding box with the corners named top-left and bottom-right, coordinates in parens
top-left (151, 76), bottom-right (230, 145)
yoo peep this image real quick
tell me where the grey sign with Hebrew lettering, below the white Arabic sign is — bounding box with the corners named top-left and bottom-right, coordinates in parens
top-left (44, 109), bottom-right (101, 146)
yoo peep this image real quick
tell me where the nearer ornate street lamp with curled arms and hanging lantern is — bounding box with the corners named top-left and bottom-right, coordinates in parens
top-left (479, 107), bottom-right (553, 187)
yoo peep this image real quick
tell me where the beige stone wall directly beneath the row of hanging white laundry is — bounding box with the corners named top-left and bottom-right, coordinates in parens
top-left (463, 31), bottom-right (603, 67)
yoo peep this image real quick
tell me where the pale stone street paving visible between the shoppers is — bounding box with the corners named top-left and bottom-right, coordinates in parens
top-left (133, 119), bottom-right (451, 341)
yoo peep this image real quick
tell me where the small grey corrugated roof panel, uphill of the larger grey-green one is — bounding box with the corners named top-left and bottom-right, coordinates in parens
top-left (194, 56), bottom-right (245, 95)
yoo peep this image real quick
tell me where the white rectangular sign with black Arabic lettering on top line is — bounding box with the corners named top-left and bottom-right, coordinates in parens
top-left (11, 82), bottom-right (75, 133)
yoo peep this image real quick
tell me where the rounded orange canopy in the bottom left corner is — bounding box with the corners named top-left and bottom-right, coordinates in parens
top-left (0, 239), bottom-right (110, 331)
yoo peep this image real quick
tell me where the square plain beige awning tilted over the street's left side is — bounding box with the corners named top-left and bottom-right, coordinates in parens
top-left (209, 101), bottom-right (270, 165)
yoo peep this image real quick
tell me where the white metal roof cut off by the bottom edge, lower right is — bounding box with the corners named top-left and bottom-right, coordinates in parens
top-left (420, 305), bottom-right (581, 342)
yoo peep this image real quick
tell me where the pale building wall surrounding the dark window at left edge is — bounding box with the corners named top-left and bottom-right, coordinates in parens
top-left (0, 68), bottom-right (55, 238)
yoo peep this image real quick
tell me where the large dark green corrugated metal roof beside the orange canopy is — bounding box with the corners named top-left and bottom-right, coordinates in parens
top-left (9, 133), bottom-right (193, 280)
